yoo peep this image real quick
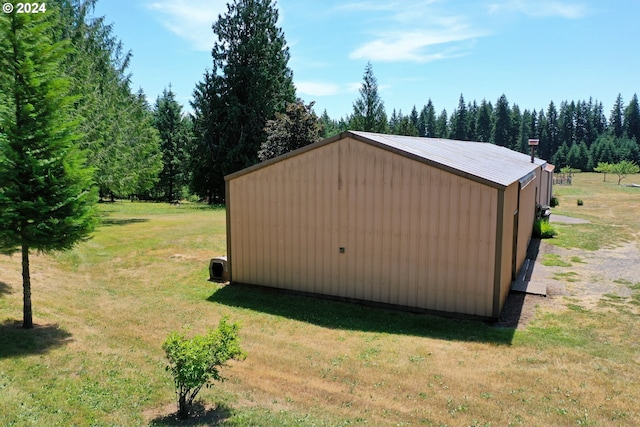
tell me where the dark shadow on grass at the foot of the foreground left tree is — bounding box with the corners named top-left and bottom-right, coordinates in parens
top-left (0, 319), bottom-right (71, 359)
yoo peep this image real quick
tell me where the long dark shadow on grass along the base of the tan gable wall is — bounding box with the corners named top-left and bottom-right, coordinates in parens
top-left (208, 284), bottom-right (515, 345)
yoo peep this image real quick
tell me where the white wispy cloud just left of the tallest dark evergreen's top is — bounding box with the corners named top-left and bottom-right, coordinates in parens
top-left (146, 0), bottom-right (227, 51)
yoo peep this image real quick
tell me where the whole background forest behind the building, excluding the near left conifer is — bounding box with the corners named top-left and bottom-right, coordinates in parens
top-left (0, 0), bottom-right (640, 203)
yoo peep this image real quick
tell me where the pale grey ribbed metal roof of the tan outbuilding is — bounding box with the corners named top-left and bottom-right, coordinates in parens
top-left (348, 131), bottom-right (547, 187)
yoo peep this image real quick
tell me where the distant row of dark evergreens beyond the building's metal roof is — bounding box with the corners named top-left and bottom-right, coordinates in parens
top-left (320, 94), bottom-right (640, 171)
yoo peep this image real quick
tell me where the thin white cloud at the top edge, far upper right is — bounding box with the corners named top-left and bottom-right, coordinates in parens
top-left (489, 0), bottom-right (588, 19)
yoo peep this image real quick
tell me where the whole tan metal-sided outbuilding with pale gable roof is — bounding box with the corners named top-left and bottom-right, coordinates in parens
top-left (225, 131), bottom-right (553, 319)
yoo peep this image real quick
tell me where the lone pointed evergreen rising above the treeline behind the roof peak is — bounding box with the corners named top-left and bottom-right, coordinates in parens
top-left (350, 62), bottom-right (389, 133)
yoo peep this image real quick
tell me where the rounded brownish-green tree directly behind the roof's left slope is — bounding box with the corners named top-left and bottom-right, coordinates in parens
top-left (258, 99), bottom-right (322, 161)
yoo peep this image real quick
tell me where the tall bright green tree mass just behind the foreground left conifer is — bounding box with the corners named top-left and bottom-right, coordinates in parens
top-left (54, 0), bottom-right (162, 201)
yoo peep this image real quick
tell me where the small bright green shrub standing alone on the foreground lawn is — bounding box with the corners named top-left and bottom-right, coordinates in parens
top-left (162, 317), bottom-right (246, 419)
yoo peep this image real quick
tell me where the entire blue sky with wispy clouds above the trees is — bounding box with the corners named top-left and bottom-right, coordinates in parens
top-left (96, 0), bottom-right (640, 119)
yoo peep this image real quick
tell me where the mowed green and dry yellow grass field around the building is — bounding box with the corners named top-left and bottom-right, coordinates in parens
top-left (0, 174), bottom-right (640, 426)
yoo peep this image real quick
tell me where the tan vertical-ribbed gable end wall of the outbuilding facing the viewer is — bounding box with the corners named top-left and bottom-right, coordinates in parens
top-left (228, 139), bottom-right (498, 317)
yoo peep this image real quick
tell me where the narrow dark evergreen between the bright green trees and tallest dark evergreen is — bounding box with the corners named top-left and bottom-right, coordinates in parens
top-left (153, 86), bottom-right (190, 201)
